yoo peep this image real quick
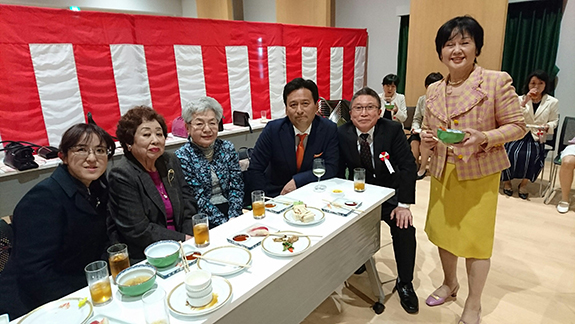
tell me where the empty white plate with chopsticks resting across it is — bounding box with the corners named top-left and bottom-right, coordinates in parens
top-left (198, 245), bottom-right (252, 276)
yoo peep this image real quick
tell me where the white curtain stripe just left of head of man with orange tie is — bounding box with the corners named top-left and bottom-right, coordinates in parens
top-left (268, 46), bottom-right (287, 119)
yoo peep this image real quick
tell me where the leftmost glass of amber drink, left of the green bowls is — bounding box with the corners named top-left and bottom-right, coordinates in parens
top-left (84, 261), bottom-right (112, 306)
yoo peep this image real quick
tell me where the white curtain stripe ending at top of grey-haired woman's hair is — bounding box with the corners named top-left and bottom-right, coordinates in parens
top-left (174, 45), bottom-right (206, 110)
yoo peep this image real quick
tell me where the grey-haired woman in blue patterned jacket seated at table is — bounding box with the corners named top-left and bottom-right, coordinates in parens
top-left (176, 97), bottom-right (244, 227)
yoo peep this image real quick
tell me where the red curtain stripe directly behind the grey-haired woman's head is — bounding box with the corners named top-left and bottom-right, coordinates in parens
top-left (202, 46), bottom-right (232, 123)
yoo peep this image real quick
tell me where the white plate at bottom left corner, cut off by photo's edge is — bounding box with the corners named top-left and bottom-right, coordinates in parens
top-left (19, 298), bottom-right (94, 324)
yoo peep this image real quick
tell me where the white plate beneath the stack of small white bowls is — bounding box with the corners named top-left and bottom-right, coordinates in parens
top-left (168, 276), bottom-right (232, 317)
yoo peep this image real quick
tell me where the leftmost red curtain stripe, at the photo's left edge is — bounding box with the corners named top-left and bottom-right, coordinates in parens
top-left (0, 44), bottom-right (49, 145)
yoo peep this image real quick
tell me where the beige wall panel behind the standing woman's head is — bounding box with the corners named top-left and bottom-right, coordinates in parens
top-left (405, 0), bottom-right (508, 106)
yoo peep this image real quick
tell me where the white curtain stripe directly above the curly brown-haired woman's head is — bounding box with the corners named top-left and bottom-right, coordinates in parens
top-left (110, 44), bottom-right (152, 115)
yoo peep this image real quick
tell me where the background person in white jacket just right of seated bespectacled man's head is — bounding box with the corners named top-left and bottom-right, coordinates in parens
top-left (379, 74), bottom-right (407, 125)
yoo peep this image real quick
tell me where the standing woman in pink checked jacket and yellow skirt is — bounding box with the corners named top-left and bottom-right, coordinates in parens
top-left (421, 16), bottom-right (526, 324)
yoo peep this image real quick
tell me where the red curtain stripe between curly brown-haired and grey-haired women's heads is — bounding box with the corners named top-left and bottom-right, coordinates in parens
top-left (144, 45), bottom-right (182, 131)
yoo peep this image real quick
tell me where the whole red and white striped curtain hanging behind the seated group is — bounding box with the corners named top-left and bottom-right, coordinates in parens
top-left (0, 5), bottom-right (367, 146)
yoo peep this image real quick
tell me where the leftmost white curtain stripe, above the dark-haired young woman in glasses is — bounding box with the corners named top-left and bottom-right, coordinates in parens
top-left (29, 44), bottom-right (85, 147)
